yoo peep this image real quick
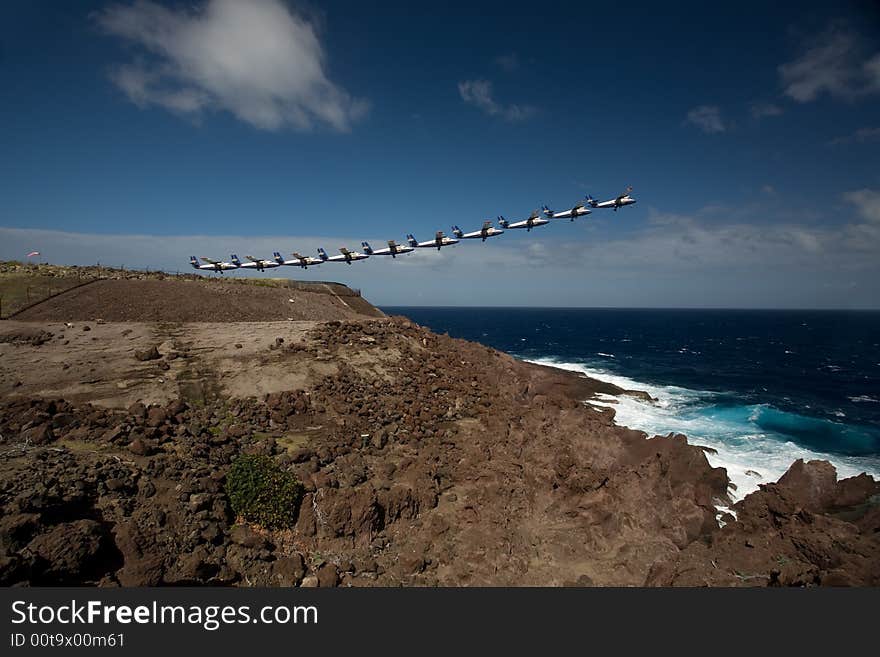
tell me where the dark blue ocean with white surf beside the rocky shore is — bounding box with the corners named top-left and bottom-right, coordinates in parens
top-left (382, 307), bottom-right (880, 498)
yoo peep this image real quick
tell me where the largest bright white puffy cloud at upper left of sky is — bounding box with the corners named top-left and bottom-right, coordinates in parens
top-left (95, 0), bottom-right (368, 131)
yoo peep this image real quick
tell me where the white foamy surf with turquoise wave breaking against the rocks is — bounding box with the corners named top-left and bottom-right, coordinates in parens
top-left (530, 358), bottom-right (880, 500)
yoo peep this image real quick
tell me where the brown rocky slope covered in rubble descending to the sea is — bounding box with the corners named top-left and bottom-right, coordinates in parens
top-left (0, 308), bottom-right (880, 586)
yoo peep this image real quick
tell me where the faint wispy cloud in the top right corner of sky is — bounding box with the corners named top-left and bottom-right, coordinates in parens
top-left (778, 26), bottom-right (880, 103)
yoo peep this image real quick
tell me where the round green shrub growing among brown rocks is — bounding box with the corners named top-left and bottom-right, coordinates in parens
top-left (226, 454), bottom-right (303, 529)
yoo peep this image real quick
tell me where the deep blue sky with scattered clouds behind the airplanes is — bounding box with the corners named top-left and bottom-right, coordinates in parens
top-left (0, 0), bottom-right (880, 308)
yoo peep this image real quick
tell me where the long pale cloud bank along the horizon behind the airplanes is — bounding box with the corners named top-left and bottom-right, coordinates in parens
top-left (6, 189), bottom-right (880, 308)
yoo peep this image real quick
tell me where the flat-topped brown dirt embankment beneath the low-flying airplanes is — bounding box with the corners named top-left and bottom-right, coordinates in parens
top-left (14, 277), bottom-right (382, 322)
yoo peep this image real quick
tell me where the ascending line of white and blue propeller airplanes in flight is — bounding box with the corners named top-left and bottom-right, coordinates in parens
top-left (189, 187), bottom-right (636, 274)
